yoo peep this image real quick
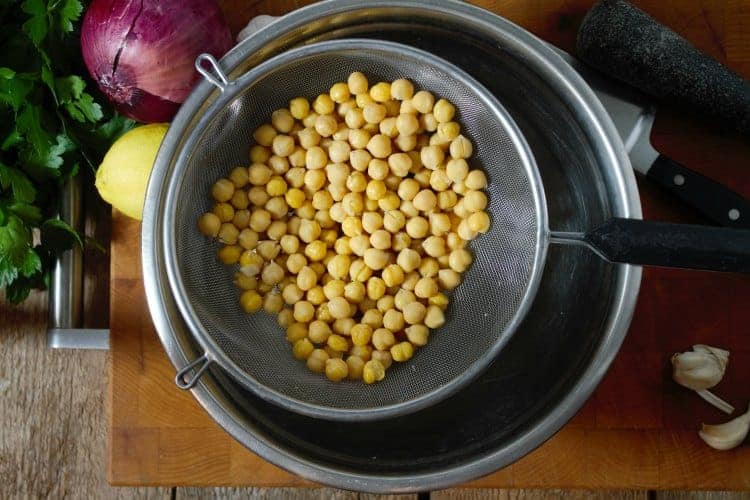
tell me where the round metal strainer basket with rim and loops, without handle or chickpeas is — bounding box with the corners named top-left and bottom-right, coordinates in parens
top-left (162, 39), bottom-right (547, 420)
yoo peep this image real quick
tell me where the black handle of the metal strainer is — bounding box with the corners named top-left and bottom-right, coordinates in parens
top-left (584, 218), bottom-right (750, 273)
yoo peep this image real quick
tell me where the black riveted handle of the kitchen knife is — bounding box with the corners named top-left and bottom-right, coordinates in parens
top-left (646, 155), bottom-right (750, 229)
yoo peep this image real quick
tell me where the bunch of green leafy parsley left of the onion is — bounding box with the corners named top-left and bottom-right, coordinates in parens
top-left (0, 0), bottom-right (133, 303)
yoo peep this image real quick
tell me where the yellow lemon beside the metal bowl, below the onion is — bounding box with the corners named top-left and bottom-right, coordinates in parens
top-left (95, 123), bottom-right (169, 220)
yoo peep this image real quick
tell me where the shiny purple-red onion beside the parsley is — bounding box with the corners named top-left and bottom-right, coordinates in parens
top-left (81, 0), bottom-right (232, 123)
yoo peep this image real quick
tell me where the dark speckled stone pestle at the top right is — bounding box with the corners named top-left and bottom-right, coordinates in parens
top-left (577, 0), bottom-right (750, 136)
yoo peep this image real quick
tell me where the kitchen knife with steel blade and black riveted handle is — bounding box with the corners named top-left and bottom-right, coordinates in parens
top-left (554, 47), bottom-right (750, 228)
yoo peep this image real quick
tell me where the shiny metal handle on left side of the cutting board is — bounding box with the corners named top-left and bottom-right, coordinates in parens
top-left (47, 177), bottom-right (109, 349)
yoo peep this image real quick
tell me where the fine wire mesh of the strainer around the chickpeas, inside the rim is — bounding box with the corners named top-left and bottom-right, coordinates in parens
top-left (167, 48), bottom-right (540, 410)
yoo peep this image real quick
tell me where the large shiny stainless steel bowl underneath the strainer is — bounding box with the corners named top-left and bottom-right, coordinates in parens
top-left (142, 0), bottom-right (641, 492)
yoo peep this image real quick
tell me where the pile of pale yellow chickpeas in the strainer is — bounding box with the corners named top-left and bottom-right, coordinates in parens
top-left (198, 72), bottom-right (490, 384)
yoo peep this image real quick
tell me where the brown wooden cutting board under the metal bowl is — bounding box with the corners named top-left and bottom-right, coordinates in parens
top-left (108, 0), bottom-right (750, 489)
